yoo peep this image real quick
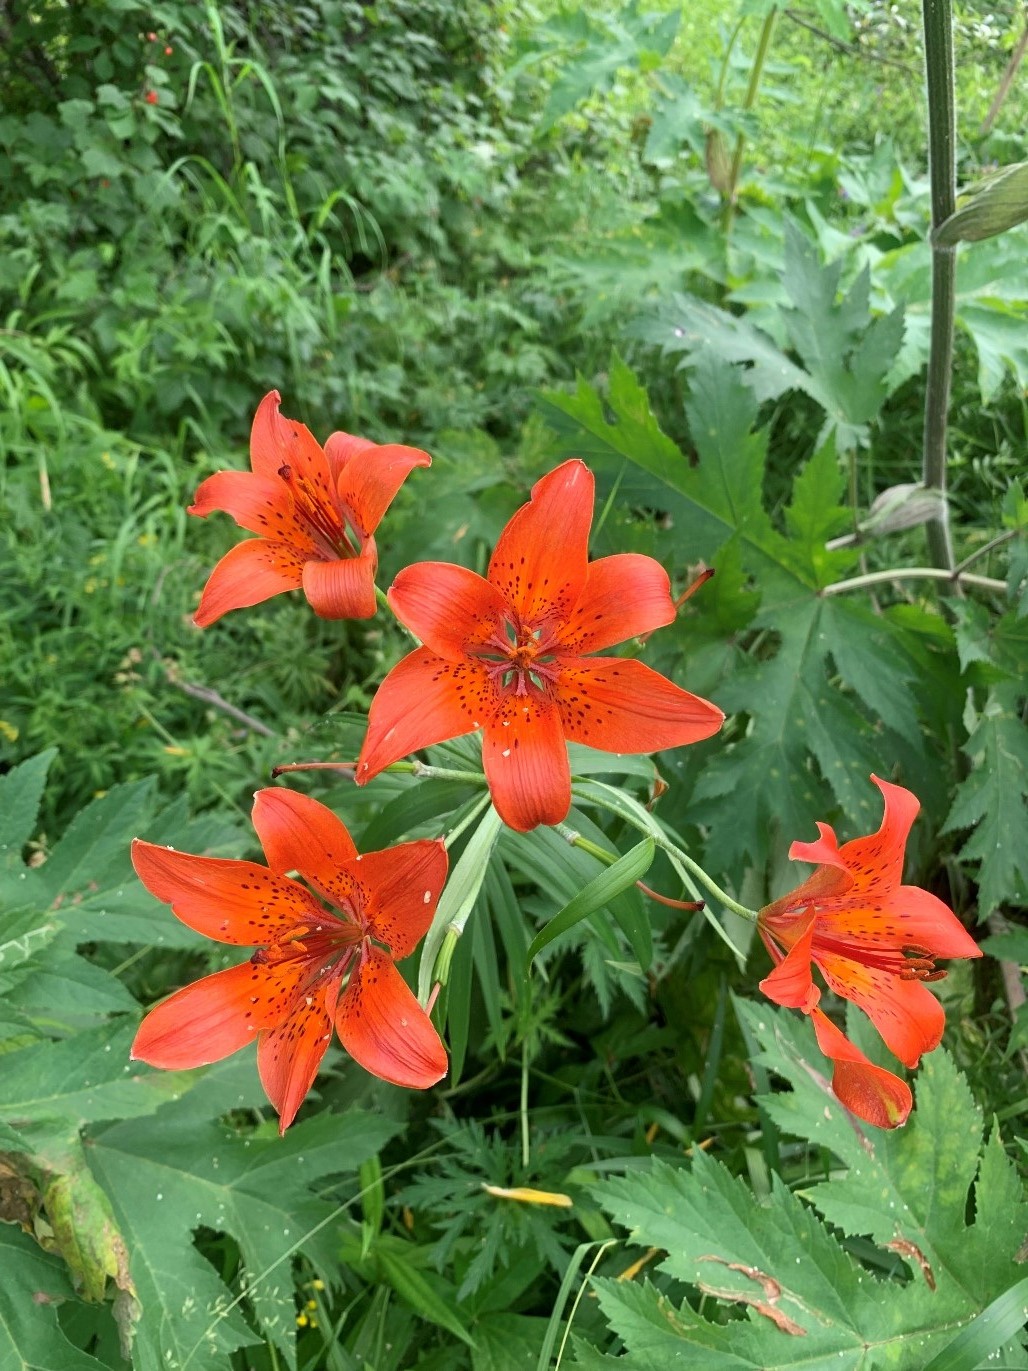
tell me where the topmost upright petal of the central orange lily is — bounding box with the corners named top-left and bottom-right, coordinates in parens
top-left (489, 459), bottom-right (595, 625)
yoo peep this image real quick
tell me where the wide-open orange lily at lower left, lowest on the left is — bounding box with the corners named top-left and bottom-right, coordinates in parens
top-left (132, 788), bottom-right (447, 1132)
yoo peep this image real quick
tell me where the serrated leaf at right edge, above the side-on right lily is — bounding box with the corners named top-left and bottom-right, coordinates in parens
top-left (944, 686), bottom-right (1028, 919)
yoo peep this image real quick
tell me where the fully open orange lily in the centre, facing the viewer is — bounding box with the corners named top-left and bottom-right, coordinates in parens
top-left (356, 461), bottom-right (725, 832)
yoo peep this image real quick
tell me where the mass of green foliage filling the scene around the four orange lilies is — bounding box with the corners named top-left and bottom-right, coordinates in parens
top-left (0, 0), bottom-right (1028, 1371)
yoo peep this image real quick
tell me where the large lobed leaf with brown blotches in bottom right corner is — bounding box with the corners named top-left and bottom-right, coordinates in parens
top-left (577, 1006), bottom-right (1028, 1371)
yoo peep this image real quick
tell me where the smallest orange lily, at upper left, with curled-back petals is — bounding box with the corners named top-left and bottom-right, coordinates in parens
top-left (189, 391), bottom-right (432, 628)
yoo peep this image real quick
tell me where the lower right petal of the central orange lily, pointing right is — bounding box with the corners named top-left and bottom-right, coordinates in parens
top-left (558, 657), bottom-right (725, 753)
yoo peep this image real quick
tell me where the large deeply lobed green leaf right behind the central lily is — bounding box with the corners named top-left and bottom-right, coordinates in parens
top-left (544, 354), bottom-right (922, 869)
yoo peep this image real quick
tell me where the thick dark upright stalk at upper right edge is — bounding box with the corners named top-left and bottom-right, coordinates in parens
top-left (921, 0), bottom-right (957, 569)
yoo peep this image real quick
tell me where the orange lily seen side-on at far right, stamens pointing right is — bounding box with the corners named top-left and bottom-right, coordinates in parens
top-left (757, 776), bottom-right (981, 1128)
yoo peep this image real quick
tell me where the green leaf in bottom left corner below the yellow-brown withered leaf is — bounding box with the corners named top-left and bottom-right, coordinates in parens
top-left (0, 1224), bottom-right (110, 1371)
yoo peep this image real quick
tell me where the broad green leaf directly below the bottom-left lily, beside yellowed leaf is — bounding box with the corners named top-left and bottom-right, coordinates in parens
top-left (88, 1106), bottom-right (397, 1371)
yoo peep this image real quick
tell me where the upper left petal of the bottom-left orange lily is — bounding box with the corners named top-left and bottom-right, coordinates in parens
top-left (132, 838), bottom-right (319, 947)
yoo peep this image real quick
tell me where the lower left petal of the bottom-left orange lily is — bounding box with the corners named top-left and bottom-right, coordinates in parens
top-left (130, 961), bottom-right (283, 1071)
